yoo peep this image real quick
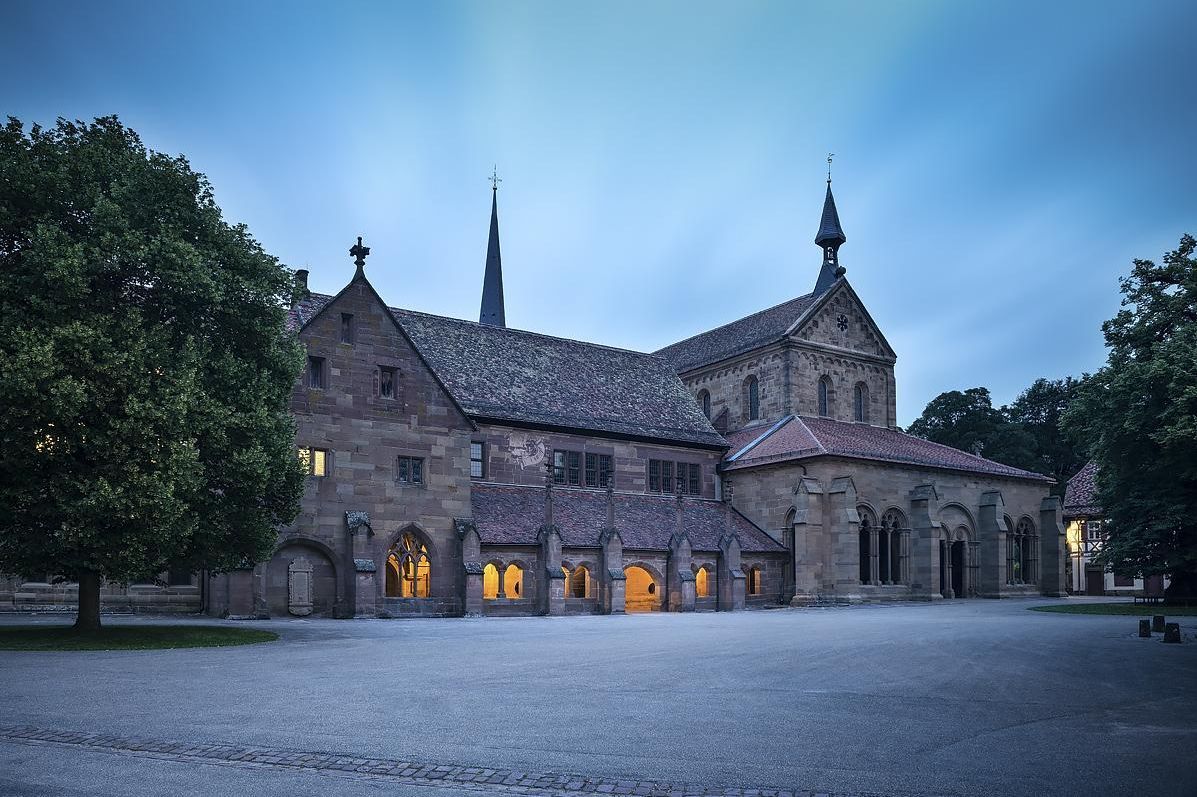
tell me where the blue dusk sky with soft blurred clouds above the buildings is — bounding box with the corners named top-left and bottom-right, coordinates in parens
top-left (0, 0), bottom-right (1197, 425)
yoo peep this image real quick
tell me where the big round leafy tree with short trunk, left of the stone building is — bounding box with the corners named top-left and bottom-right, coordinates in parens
top-left (0, 117), bottom-right (303, 629)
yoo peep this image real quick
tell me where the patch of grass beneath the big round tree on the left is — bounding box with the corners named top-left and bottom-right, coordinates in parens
top-left (0, 625), bottom-right (279, 650)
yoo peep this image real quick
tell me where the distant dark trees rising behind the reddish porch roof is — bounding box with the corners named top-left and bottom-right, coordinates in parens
top-left (906, 388), bottom-right (1034, 469)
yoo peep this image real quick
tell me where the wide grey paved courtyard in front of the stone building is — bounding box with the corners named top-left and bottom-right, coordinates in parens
top-left (0, 601), bottom-right (1197, 797)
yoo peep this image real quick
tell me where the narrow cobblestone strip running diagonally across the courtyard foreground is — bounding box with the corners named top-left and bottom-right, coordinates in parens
top-left (0, 725), bottom-right (933, 797)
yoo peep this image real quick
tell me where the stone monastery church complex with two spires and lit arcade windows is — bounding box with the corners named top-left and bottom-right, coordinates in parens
top-left (0, 181), bottom-right (1065, 617)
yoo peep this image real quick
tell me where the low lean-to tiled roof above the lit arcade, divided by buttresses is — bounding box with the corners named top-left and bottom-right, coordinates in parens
top-left (470, 482), bottom-right (784, 553)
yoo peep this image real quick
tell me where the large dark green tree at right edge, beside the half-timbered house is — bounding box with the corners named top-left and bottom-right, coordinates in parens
top-left (1064, 235), bottom-right (1197, 598)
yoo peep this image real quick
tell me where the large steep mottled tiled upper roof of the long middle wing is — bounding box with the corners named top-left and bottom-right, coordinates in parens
top-left (291, 293), bottom-right (727, 449)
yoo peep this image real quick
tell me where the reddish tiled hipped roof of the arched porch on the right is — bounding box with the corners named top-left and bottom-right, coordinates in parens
top-left (727, 415), bottom-right (1051, 481)
